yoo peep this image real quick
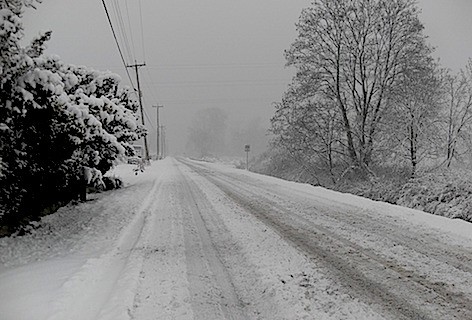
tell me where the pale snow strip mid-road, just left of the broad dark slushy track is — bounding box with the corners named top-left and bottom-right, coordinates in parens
top-left (179, 162), bottom-right (312, 320)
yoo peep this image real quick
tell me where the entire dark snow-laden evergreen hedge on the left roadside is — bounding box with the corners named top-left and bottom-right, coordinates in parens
top-left (0, 0), bottom-right (145, 232)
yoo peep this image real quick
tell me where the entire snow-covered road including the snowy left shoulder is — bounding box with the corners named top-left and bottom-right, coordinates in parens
top-left (0, 158), bottom-right (472, 320)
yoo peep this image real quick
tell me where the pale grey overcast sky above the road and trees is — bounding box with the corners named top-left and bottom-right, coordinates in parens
top-left (24, 0), bottom-right (472, 152)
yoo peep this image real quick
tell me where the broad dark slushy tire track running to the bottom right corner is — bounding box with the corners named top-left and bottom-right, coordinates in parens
top-left (181, 162), bottom-right (472, 319)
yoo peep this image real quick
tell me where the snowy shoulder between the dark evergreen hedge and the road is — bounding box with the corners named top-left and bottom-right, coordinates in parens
top-left (0, 164), bottom-right (164, 320)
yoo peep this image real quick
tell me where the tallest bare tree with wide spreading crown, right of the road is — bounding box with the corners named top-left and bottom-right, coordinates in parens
top-left (286, 0), bottom-right (434, 169)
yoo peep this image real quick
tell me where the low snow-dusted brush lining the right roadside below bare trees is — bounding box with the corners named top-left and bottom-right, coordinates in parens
top-left (251, 150), bottom-right (472, 222)
